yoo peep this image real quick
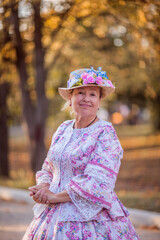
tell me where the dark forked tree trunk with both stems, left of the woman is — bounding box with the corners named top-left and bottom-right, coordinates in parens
top-left (12, 3), bottom-right (47, 172)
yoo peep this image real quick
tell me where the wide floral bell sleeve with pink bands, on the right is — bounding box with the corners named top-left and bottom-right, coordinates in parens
top-left (68, 126), bottom-right (123, 220)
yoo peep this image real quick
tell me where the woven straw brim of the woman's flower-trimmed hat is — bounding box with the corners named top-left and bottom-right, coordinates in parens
top-left (58, 84), bottom-right (115, 100)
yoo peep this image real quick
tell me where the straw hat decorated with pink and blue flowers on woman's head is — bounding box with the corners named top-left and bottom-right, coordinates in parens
top-left (58, 67), bottom-right (115, 100)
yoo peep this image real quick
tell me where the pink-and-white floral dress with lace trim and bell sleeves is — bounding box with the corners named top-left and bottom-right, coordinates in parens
top-left (23, 120), bottom-right (139, 240)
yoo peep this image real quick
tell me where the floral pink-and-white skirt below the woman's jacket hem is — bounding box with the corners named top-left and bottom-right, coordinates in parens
top-left (22, 204), bottom-right (139, 240)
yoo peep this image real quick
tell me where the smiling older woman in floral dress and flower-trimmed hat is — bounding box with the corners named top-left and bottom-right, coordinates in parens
top-left (23, 68), bottom-right (139, 240)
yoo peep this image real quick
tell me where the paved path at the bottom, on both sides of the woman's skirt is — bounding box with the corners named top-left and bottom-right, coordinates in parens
top-left (0, 200), bottom-right (160, 240)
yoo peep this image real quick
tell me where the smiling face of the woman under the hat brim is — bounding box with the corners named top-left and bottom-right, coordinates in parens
top-left (71, 86), bottom-right (100, 117)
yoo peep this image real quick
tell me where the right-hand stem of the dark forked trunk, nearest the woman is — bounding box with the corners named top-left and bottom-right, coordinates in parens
top-left (31, 1), bottom-right (48, 171)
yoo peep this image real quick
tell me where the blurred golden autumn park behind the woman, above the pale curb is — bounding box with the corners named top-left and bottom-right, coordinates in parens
top-left (0, 0), bottom-right (160, 212)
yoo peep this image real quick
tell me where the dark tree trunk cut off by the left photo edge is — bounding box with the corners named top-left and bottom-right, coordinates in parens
top-left (0, 83), bottom-right (9, 177)
